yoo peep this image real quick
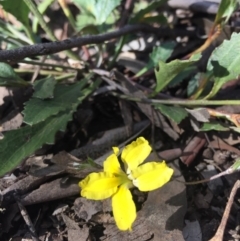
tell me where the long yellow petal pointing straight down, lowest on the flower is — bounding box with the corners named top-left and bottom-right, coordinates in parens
top-left (112, 185), bottom-right (137, 231)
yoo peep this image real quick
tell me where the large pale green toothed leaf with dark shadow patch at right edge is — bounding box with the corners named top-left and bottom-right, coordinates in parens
top-left (205, 33), bottom-right (240, 99)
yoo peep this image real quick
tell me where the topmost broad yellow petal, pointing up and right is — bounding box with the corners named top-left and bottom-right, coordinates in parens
top-left (121, 137), bottom-right (152, 173)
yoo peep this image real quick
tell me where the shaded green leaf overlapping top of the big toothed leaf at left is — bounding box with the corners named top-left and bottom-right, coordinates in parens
top-left (23, 79), bottom-right (100, 125)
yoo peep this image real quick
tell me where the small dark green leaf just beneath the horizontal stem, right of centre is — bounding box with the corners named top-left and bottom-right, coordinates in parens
top-left (154, 104), bottom-right (188, 124)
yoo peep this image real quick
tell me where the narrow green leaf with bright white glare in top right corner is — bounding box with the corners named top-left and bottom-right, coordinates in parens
top-left (214, 0), bottom-right (238, 24)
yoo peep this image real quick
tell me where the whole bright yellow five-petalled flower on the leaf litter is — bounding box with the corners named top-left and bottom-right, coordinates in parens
top-left (79, 137), bottom-right (173, 230)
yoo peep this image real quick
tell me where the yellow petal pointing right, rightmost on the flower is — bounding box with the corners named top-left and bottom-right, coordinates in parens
top-left (132, 162), bottom-right (173, 191)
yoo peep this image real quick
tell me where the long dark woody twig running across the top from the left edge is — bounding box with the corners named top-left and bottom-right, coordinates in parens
top-left (0, 24), bottom-right (194, 62)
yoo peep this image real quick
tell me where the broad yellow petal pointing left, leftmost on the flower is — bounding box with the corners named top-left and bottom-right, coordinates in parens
top-left (79, 172), bottom-right (122, 200)
